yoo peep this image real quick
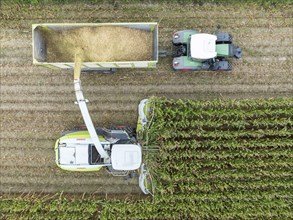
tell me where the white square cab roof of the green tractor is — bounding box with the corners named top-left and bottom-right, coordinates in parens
top-left (190, 34), bottom-right (217, 60)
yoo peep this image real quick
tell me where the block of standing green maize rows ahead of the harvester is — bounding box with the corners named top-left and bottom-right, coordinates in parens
top-left (102, 97), bottom-right (293, 219)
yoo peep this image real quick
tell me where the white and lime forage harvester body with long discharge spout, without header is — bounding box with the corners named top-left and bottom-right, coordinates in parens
top-left (55, 62), bottom-right (142, 175)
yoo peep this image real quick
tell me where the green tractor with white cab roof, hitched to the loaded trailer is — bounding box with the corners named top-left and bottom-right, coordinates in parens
top-left (172, 30), bottom-right (242, 71)
